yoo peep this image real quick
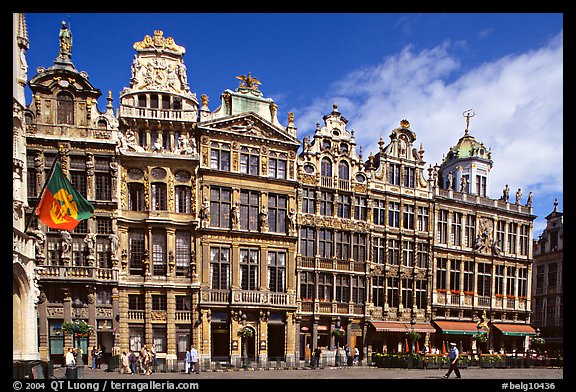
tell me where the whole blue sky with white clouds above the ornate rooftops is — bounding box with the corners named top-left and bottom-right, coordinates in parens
top-left (26, 12), bottom-right (563, 238)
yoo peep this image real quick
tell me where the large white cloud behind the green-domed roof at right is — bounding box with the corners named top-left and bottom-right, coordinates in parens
top-left (294, 33), bottom-right (563, 220)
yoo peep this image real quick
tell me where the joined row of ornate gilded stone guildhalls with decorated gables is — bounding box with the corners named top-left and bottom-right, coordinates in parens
top-left (15, 16), bottom-right (535, 366)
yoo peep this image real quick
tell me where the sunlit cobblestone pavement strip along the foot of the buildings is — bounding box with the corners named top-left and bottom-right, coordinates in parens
top-left (54, 367), bottom-right (564, 380)
